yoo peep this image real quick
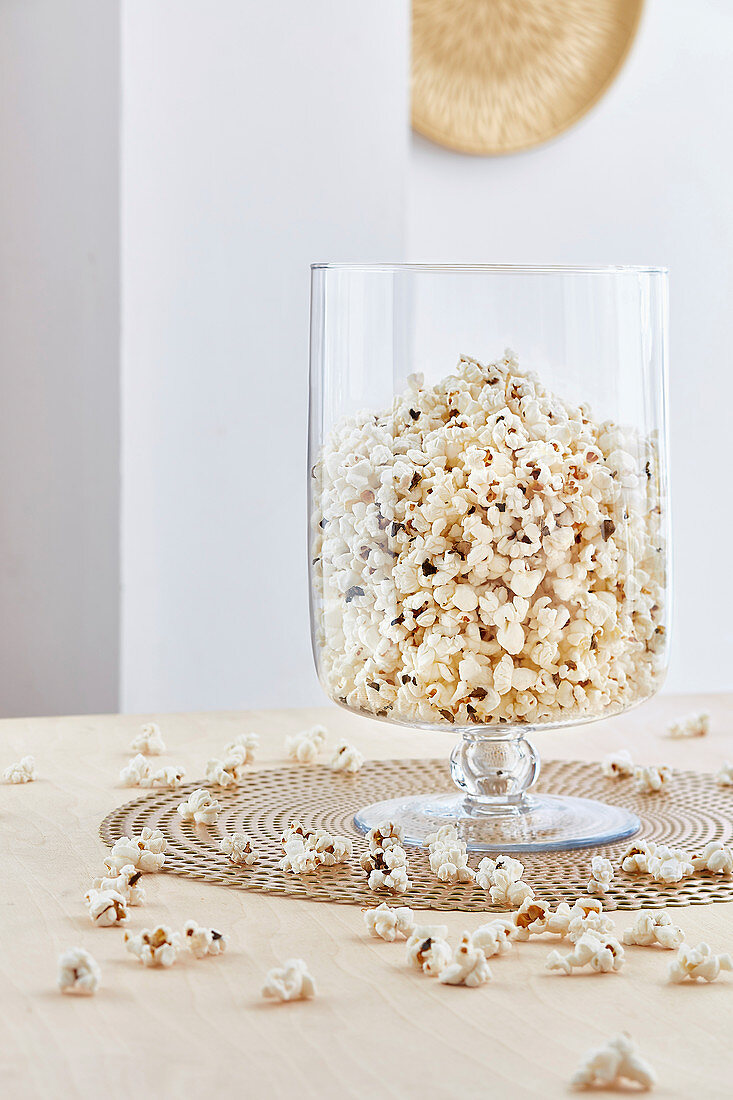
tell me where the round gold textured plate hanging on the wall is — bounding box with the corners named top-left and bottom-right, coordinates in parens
top-left (412, 0), bottom-right (643, 154)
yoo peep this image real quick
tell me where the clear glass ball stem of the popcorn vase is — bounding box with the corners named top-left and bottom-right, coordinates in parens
top-left (450, 732), bottom-right (539, 814)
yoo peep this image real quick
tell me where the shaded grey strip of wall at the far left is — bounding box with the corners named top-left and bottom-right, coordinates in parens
top-left (0, 0), bottom-right (119, 716)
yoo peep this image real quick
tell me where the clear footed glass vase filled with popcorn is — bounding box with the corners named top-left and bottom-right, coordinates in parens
top-left (309, 264), bottom-right (669, 851)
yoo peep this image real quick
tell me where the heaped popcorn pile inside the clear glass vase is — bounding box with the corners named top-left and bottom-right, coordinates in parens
top-left (313, 351), bottom-right (665, 725)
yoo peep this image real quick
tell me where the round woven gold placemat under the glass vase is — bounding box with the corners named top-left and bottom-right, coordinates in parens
top-left (99, 760), bottom-right (733, 912)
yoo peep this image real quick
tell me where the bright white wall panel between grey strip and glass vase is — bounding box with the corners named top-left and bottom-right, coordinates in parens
top-left (121, 0), bottom-right (408, 711)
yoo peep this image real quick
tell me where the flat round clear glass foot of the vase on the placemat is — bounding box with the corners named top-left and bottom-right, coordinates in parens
top-left (353, 793), bottom-right (642, 853)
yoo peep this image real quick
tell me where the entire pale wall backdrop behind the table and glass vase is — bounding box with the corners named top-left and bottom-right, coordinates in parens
top-left (0, 0), bottom-right (733, 714)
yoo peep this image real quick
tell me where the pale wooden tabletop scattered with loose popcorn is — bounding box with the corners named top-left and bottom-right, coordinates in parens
top-left (0, 695), bottom-right (733, 1100)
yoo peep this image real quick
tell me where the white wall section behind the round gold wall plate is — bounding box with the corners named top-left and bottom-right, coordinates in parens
top-left (407, 0), bottom-right (733, 691)
